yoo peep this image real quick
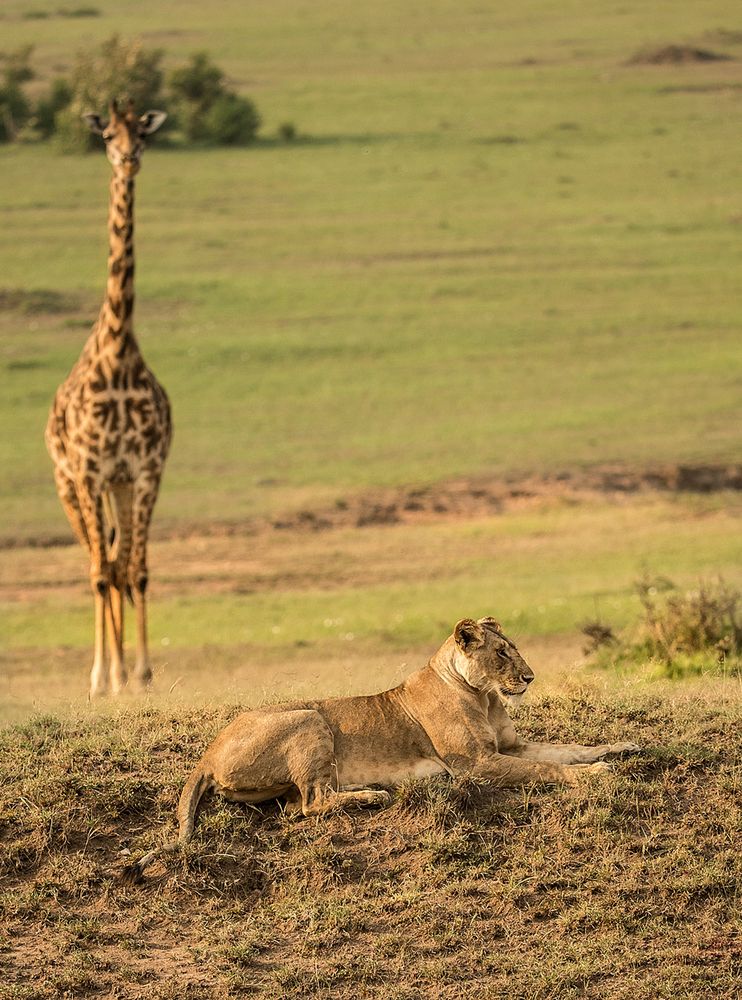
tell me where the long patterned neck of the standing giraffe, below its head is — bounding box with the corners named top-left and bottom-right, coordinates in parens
top-left (96, 171), bottom-right (137, 358)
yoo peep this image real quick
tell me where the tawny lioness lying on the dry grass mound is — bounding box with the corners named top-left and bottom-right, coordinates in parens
top-left (125, 618), bottom-right (639, 881)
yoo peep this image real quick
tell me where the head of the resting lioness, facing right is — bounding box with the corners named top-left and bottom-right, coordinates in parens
top-left (453, 618), bottom-right (533, 706)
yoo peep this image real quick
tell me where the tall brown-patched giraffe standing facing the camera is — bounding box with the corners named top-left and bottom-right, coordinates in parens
top-left (45, 101), bottom-right (172, 697)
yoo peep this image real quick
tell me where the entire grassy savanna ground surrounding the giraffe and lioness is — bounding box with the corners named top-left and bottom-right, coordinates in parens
top-left (0, 0), bottom-right (742, 1000)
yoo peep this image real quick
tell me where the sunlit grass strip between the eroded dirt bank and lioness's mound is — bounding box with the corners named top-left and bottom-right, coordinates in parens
top-left (0, 496), bottom-right (742, 716)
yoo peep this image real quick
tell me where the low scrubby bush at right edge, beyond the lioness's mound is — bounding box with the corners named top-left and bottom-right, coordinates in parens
top-left (583, 577), bottom-right (742, 677)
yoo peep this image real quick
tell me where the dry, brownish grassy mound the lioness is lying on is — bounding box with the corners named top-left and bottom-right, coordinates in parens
top-left (0, 682), bottom-right (740, 1000)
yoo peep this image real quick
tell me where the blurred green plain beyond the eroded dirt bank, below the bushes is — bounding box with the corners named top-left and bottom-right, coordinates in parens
top-left (0, 2), bottom-right (740, 538)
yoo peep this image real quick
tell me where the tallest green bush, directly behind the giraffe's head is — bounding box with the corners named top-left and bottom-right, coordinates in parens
top-left (55, 35), bottom-right (163, 152)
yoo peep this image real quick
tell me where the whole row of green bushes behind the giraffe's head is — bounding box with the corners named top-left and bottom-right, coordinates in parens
top-left (0, 35), bottom-right (268, 152)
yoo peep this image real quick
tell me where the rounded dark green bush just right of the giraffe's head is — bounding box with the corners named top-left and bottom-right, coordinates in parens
top-left (170, 52), bottom-right (260, 145)
